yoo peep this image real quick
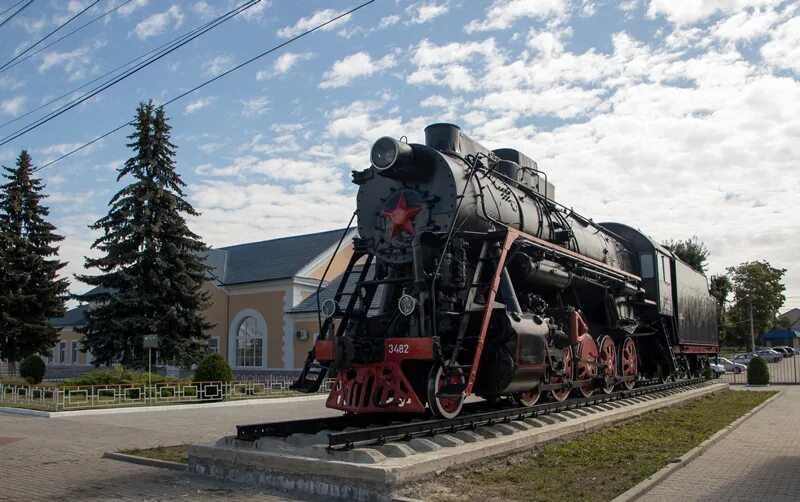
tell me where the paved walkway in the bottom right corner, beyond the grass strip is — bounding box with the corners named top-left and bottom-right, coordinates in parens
top-left (642, 386), bottom-right (800, 502)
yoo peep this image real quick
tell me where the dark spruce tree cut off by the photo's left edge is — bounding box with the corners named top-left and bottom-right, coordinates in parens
top-left (0, 150), bottom-right (69, 370)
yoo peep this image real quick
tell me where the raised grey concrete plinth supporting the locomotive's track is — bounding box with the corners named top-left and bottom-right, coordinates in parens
top-left (189, 384), bottom-right (728, 501)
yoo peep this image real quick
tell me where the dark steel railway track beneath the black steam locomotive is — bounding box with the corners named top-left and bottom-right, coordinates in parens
top-left (236, 378), bottom-right (713, 450)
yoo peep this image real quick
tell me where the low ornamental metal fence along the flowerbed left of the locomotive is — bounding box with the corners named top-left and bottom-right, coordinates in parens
top-left (0, 376), bottom-right (332, 411)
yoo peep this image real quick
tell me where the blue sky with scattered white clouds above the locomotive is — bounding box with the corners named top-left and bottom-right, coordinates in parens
top-left (0, 0), bottom-right (800, 308)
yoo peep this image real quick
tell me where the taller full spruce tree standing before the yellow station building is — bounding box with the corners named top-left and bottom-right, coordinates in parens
top-left (78, 101), bottom-right (212, 368)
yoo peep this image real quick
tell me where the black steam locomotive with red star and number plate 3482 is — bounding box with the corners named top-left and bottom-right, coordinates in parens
top-left (294, 124), bottom-right (718, 418)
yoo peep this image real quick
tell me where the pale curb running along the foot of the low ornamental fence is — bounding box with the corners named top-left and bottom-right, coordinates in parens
top-left (0, 394), bottom-right (328, 418)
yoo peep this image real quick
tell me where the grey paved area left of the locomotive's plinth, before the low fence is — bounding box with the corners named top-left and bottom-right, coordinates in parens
top-left (0, 399), bottom-right (336, 501)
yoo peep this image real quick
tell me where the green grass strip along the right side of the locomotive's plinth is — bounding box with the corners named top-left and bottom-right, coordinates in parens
top-left (406, 390), bottom-right (775, 501)
